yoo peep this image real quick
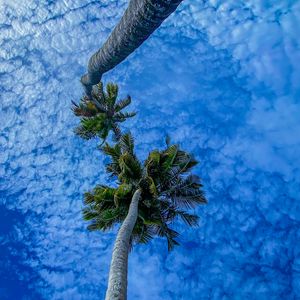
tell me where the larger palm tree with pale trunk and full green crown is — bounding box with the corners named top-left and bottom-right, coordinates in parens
top-left (83, 133), bottom-right (206, 300)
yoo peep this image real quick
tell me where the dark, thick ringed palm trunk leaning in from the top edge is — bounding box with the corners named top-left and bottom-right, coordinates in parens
top-left (81, 0), bottom-right (183, 96)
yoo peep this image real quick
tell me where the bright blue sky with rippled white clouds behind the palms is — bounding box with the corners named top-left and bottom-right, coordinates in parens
top-left (0, 0), bottom-right (300, 300)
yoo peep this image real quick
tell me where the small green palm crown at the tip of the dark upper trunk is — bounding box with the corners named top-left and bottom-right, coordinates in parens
top-left (72, 82), bottom-right (136, 144)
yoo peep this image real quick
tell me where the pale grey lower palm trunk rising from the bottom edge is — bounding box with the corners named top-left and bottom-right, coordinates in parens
top-left (105, 190), bottom-right (141, 300)
